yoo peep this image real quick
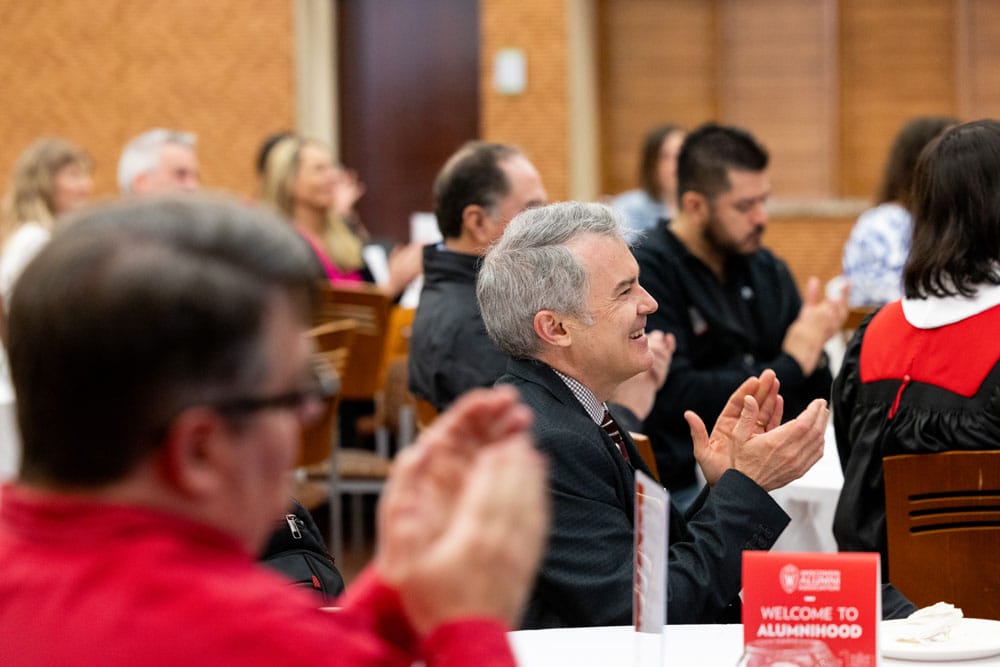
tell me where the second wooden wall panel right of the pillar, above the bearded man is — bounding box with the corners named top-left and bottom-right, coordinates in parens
top-left (719, 0), bottom-right (837, 198)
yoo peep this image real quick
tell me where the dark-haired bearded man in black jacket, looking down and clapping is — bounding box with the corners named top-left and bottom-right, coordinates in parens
top-left (634, 124), bottom-right (847, 506)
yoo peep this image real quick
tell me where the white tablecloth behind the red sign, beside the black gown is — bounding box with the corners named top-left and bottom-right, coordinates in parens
top-left (771, 423), bottom-right (844, 553)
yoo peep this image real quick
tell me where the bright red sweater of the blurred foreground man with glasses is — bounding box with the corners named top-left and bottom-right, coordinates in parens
top-left (0, 486), bottom-right (514, 667)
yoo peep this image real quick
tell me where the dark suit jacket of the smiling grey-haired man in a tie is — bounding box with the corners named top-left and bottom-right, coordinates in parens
top-left (499, 359), bottom-right (789, 628)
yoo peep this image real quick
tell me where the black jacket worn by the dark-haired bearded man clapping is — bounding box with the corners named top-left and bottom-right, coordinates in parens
top-left (633, 222), bottom-right (832, 489)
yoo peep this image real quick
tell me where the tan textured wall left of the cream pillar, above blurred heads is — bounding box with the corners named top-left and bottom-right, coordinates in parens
top-left (0, 0), bottom-right (294, 202)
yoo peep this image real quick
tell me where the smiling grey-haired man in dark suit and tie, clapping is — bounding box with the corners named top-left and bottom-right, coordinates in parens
top-left (477, 202), bottom-right (829, 628)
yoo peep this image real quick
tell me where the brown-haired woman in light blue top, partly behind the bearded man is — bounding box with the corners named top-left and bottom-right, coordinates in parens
top-left (611, 125), bottom-right (686, 239)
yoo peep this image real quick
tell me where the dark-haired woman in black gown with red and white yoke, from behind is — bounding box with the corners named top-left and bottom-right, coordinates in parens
top-left (833, 120), bottom-right (1000, 572)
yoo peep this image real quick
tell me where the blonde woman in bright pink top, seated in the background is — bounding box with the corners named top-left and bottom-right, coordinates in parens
top-left (261, 135), bottom-right (420, 296)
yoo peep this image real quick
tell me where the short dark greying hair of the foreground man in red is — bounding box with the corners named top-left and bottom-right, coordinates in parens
top-left (7, 194), bottom-right (316, 487)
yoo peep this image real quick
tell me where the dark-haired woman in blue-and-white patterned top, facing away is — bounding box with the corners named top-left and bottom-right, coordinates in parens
top-left (842, 116), bottom-right (958, 306)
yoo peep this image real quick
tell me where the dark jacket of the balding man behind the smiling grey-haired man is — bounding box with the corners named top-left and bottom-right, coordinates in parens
top-left (409, 245), bottom-right (507, 410)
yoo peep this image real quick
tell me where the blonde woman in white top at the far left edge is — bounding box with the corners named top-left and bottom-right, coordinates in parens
top-left (0, 137), bottom-right (93, 304)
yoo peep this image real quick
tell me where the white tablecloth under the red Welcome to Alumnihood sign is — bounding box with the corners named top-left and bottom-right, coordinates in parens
top-left (509, 625), bottom-right (1000, 667)
